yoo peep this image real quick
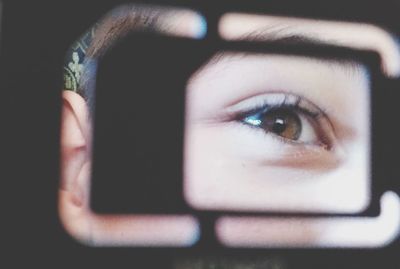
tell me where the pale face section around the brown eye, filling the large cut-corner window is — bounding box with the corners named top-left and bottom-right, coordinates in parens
top-left (184, 52), bottom-right (370, 212)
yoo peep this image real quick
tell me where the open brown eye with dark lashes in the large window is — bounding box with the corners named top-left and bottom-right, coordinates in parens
top-left (235, 93), bottom-right (335, 150)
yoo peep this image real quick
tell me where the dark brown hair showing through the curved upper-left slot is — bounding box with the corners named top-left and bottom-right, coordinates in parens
top-left (65, 4), bottom-right (191, 112)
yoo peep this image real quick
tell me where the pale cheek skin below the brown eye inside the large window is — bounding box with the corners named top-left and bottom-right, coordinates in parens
top-left (184, 124), bottom-right (369, 213)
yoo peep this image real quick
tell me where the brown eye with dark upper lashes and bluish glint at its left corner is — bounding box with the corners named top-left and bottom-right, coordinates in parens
top-left (238, 93), bottom-right (332, 149)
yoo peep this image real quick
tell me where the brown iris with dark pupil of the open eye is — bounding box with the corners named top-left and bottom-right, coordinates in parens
top-left (260, 109), bottom-right (302, 141)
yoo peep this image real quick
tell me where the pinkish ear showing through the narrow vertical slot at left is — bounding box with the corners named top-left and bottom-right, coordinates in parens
top-left (59, 91), bottom-right (92, 241)
